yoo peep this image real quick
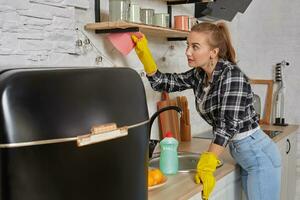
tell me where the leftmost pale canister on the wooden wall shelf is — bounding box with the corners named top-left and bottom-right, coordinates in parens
top-left (109, 0), bottom-right (129, 21)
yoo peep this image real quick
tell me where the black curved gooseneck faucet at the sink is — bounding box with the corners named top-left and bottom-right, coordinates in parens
top-left (148, 106), bottom-right (182, 158)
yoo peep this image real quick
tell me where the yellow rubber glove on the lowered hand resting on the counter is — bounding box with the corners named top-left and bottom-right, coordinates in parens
top-left (195, 152), bottom-right (220, 200)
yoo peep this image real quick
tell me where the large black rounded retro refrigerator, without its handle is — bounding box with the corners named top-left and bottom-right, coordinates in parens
top-left (0, 67), bottom-right (149, 200)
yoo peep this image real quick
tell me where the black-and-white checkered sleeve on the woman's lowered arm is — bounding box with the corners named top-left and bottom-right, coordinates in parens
top-left (213, 67), bottom-right (251, 147)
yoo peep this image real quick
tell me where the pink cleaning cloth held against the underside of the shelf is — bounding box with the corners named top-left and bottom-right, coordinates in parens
top-left (107, 32), bottom-right (143, 56)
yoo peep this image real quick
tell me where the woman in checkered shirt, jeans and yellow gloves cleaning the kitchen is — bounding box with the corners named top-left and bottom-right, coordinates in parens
top-left (132, 22), bottom-right (281, 200)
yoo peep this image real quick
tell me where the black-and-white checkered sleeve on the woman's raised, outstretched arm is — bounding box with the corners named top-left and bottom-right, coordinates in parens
top-left (147, 69), bottom-right (196, 92)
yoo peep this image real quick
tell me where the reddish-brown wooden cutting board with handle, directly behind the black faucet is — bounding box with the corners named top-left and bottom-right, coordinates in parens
top-left (157, 92), bottom-right (181, 142)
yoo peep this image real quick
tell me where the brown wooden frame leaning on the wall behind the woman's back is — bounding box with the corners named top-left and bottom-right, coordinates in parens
top-left (250, 79), bottom-right (273, 125)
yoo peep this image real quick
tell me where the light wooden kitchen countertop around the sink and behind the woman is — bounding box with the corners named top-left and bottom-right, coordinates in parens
top-left (148, 125), bottom-right (299, 200)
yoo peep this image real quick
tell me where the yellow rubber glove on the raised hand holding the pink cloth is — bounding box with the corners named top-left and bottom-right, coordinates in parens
top-left (131, 34), bottom-right (157, 74)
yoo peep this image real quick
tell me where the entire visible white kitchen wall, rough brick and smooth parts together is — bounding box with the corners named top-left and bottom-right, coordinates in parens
top-left (0, 0), bottom-right (300, 198)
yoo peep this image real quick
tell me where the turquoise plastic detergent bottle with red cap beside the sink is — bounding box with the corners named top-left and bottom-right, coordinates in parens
top-left (159, 132), bottom-right (178, 175)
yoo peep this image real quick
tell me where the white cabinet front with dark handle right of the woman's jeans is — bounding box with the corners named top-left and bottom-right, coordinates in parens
top-left (277, 132), bottom-right (297, 200)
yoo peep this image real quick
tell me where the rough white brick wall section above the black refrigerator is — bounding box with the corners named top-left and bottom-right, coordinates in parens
top-left (0, 0), bottom-right (89, 67)
